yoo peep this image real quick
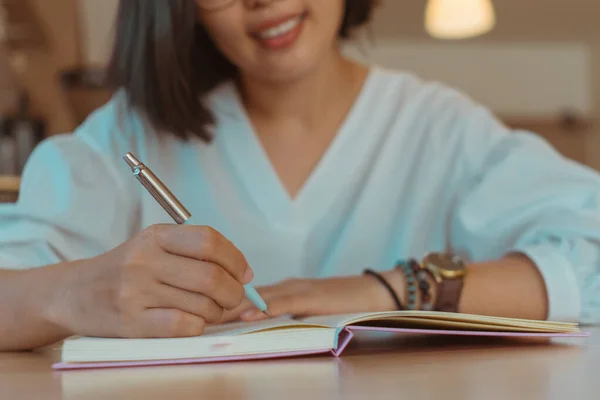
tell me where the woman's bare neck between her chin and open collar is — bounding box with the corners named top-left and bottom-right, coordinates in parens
top-left (240, 52), bottom-right (366, 131)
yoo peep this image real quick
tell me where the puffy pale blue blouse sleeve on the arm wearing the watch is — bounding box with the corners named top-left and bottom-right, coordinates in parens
top-left (451, 96), bottom-right (600, 324)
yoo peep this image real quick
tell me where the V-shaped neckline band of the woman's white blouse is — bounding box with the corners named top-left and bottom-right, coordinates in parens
top-left (211, 67), bottom-right (378, 229)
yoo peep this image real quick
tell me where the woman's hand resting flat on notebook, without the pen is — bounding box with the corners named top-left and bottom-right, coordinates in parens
top-left (240, 276), bottom-right (396, 321)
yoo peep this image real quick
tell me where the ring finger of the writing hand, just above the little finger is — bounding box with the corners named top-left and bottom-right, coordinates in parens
top-left (147, 285), bottom-right (224, 323)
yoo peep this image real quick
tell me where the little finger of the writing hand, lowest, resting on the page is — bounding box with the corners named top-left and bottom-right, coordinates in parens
top-left (123, 308), bottom-right (206, 338)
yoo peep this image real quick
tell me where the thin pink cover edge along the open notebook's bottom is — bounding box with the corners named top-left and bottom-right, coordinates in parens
top-left (52, 326), bottom-right (590, 371)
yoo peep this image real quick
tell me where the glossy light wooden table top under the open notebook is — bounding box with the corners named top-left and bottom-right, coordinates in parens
top-left (0, 328), bottom-right (600, 400)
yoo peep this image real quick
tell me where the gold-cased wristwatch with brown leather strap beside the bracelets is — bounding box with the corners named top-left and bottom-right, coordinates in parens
top-left (421, 253), bottom-right (467, 312)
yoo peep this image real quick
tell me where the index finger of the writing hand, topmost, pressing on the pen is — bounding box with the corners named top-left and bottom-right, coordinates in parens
top-left (151, 225), bottom-right (254, 284)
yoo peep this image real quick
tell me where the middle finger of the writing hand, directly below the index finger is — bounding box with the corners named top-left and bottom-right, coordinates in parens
top-left (155, 254), bottom-right (245, 310)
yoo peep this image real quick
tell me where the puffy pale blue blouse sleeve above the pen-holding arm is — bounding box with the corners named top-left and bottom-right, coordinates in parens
top-left (0, 134), bottom-right (135, 269)
